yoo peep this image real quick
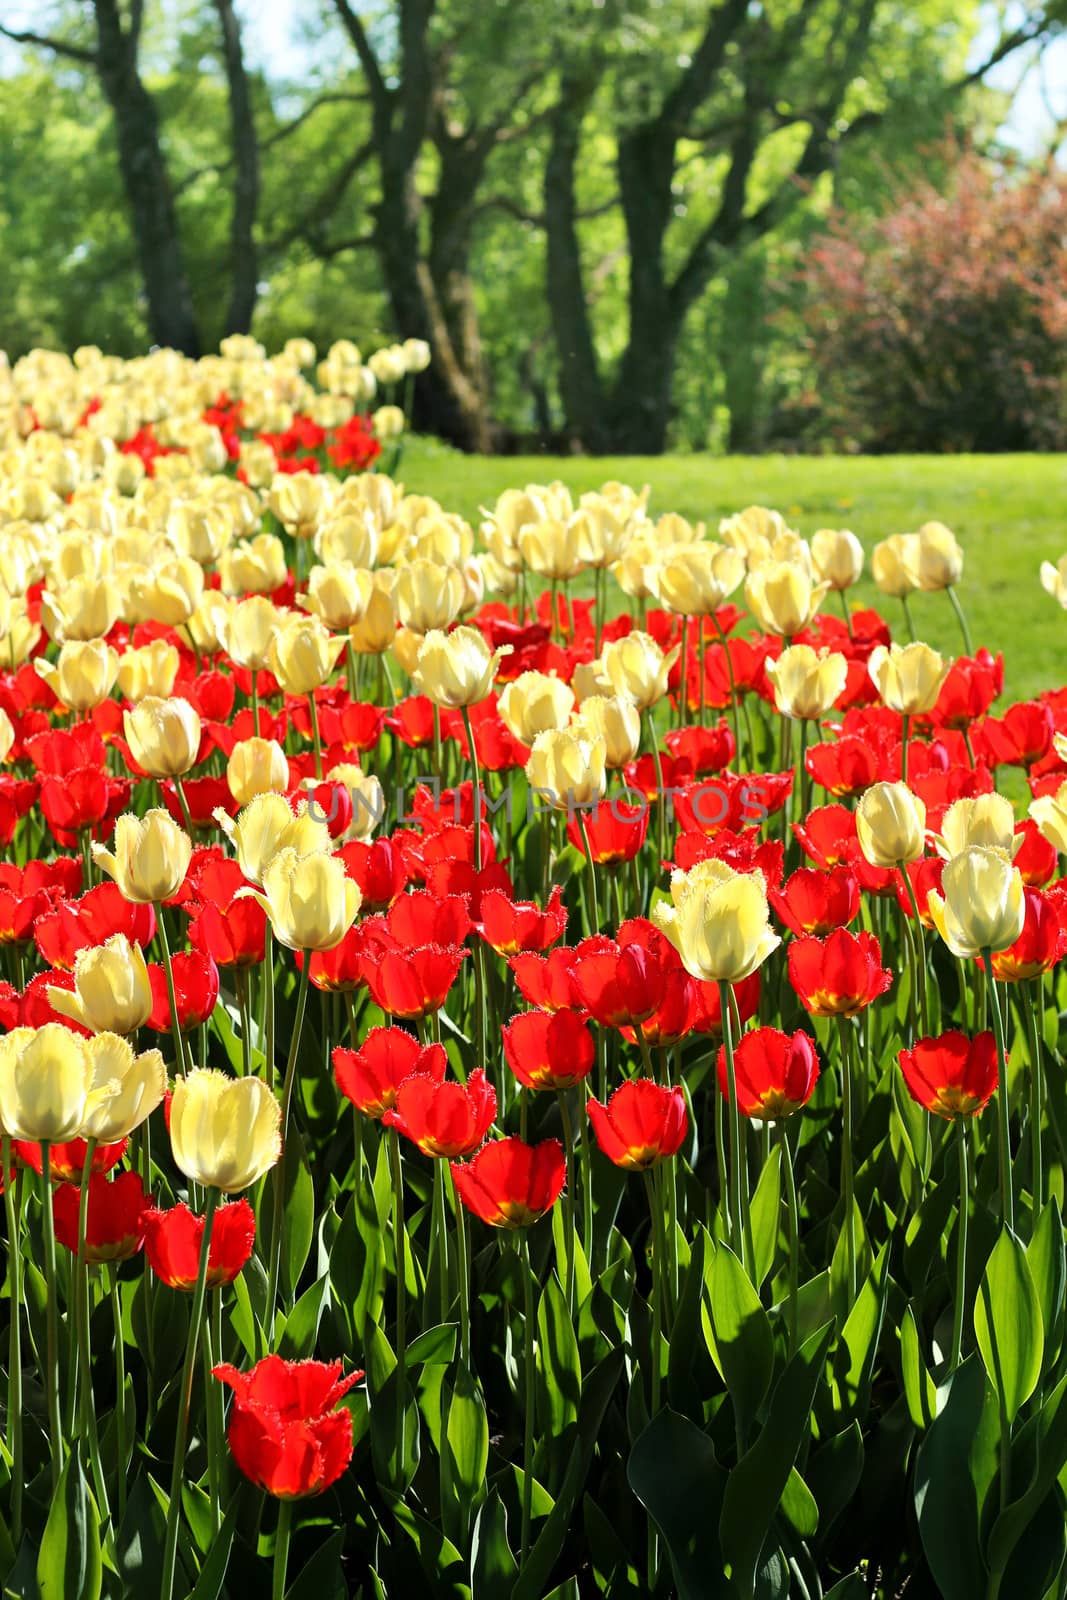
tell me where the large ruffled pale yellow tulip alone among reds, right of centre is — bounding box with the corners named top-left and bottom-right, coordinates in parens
top-left (653, 858), bottom-right (782, 984)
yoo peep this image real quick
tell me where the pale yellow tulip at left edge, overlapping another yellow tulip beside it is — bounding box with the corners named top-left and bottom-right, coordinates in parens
top-left (0, 1022), bottom-right (93, 1152)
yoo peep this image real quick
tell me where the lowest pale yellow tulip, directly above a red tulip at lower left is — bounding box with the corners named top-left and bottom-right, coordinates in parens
top-left (170, 1067), bottom-right (282, 1194)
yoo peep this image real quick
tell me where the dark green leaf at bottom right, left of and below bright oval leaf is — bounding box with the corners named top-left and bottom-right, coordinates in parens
top-left (915, 1355), bottom-right (985, 1600)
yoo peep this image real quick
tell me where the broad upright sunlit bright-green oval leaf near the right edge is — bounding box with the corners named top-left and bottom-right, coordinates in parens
top-left (974, 1227), bottom-right (1045, 1422)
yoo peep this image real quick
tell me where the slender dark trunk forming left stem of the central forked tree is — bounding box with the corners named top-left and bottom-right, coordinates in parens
top-left (544, 74), bottom-right (606, 453)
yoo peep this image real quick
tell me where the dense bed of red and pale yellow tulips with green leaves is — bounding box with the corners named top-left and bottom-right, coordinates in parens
top-left (0, 338), bottom-right (1067, 1600)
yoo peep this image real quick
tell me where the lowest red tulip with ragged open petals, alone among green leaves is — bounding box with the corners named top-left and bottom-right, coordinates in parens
top-left (213, 1355), bottom-right (363, 1501)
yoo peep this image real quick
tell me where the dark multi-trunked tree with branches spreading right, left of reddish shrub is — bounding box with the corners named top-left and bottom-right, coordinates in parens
top-left (544, 0), bottom-right (1062, 453)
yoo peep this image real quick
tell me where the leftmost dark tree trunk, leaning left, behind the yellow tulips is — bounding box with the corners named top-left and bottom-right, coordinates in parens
top-left (94, 0), bottom-right (200, 355)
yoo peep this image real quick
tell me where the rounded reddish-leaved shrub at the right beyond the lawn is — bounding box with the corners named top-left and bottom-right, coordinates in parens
top-left (805, 155), bottom-right (1067, 451)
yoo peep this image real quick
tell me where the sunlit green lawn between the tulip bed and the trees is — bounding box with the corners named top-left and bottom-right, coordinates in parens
top-left (400, 442), bottom-right (1067, 699)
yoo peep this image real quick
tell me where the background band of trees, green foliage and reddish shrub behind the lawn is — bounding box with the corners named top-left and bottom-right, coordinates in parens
top-left (0, 0), bottom-right (1067, 453)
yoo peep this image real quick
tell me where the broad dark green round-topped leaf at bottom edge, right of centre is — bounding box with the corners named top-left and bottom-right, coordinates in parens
top-left (625, 1406), bottom-right (728, 1600)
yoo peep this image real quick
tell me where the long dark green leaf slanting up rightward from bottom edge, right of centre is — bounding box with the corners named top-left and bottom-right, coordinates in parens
top-left (718, 1322), bottom-right (833, 1595)
